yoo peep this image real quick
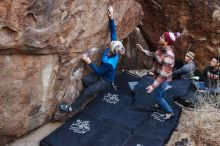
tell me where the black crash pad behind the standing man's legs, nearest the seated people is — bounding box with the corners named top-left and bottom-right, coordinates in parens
top-left (133, 76), bottom-right (197, 110)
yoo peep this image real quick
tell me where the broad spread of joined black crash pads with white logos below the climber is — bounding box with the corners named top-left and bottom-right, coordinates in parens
top-left (40, 72), bottom-right (181, 146)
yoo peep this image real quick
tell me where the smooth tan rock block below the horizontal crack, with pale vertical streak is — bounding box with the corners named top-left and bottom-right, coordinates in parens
top-left (0, 54), bottom-right (59, 143)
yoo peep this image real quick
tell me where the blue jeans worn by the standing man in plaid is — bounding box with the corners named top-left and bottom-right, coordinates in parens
top-left (154, 81), bottom-right (173, 113)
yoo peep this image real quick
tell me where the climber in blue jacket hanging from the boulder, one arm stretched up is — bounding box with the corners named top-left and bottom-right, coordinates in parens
top-left (59, 6), bottom-right (125, 112)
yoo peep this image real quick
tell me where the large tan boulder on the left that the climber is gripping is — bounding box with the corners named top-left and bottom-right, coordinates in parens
top-left (0, 0), bottom-right (143, 145)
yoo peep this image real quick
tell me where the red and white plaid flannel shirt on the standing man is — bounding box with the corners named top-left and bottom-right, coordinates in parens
top-left (145, 47), bottom-right (175, 89)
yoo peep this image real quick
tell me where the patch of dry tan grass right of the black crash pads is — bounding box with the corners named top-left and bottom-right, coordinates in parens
top-left (167, 81), bottom-right (220, 146)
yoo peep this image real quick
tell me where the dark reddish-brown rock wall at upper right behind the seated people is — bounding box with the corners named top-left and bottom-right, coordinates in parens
top-left (139, 0), bottom-right (220, 69)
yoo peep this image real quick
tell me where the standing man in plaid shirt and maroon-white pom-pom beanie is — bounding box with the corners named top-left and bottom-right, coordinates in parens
top-left (137, 32), bottom-right (180, 119)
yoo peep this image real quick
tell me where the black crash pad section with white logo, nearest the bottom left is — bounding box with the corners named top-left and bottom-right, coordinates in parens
top-left (40, 113), bottom-right (104, 146)
